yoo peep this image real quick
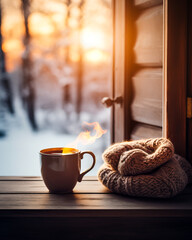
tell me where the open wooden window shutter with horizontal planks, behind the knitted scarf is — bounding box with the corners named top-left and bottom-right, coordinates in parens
top-left (113, 0), bottom-right (163, 142)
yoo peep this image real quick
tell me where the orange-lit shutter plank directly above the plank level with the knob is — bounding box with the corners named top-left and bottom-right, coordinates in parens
top-left (134, 5), bottom-right (163, 67)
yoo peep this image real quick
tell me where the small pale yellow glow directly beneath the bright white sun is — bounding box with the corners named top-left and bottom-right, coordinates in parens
top-left (85, 49), bottom-right (108, 63)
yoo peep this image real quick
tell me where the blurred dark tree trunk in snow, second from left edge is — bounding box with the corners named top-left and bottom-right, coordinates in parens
top-left (21, 0), bottom-right (37, 130)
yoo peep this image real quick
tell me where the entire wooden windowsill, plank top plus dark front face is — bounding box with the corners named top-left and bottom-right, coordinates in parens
top-left (0, 177), bottom-right (192, 239)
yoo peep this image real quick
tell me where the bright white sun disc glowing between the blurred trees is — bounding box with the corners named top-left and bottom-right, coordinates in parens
top-left (81, 28), bottom-right (105, 49)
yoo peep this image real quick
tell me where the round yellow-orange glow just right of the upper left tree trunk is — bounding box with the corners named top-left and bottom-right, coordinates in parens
top-left (29, 13), bottom-right (54, 35)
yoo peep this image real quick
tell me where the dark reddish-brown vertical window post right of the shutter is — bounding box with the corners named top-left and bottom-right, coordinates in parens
top-left (163, 0), bottom-right (187, 157)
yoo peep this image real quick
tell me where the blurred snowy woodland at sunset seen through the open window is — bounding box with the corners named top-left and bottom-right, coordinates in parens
top-left (0, 0), bottom-right (112, 176)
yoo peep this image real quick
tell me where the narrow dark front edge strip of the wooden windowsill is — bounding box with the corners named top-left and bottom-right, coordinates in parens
top-left (0, 208), bottom-right (192, 221)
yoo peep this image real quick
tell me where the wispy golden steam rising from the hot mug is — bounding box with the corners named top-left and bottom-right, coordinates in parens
top-left (63, 122), bottom-right (107, 153)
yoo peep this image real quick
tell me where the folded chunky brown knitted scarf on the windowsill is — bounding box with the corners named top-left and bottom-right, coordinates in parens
top-left (98, 138), bottom-right (192, 198)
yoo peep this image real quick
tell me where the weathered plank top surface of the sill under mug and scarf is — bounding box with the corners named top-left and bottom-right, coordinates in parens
top-left (0, 177), bottom-right (192, 211)
